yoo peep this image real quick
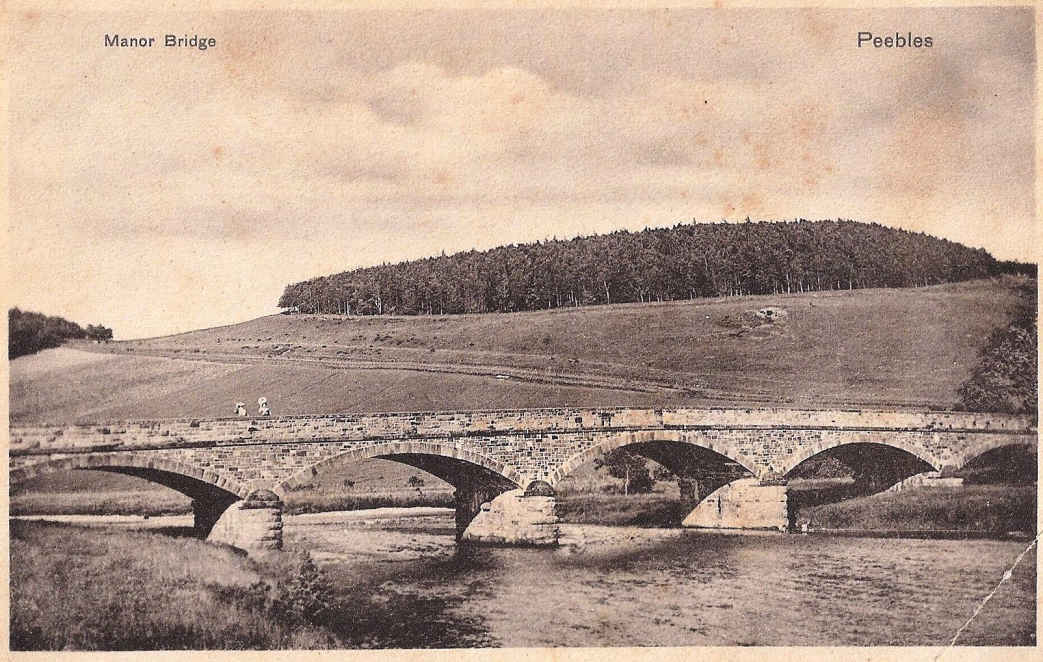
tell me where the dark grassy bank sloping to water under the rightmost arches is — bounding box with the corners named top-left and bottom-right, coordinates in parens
top-left (794, 485), bottom-right (1036, 535)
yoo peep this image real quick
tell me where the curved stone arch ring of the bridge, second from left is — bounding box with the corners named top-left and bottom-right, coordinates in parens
top-left (273, 441), bottom-right (524, 498)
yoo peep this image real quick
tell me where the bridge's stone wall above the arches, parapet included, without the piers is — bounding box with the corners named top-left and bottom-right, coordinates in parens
top-left (9, 409), bottom-right (1036, 489)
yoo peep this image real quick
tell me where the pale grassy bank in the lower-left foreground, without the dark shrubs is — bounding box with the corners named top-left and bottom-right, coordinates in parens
top-left (10, 521), bottom-right (334, 651)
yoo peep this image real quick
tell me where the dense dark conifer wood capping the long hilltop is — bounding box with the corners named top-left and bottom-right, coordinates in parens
top-left (278, 220), bottom-right (1001, 315)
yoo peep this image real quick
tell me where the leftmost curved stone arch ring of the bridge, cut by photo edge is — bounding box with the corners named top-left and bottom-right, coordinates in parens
top-left (8, 452), bottom-right (251, 502)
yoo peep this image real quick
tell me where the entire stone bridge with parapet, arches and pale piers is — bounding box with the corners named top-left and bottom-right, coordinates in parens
top-left (9, 408), bottom-right (1037, 548)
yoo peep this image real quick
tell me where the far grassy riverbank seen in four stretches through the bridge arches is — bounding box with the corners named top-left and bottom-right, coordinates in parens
top-left (10, 485), bottom-right (1037, 537)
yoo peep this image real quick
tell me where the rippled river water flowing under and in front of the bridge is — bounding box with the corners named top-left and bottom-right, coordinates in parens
top-left (16, 509), bottom-right (1036, 647)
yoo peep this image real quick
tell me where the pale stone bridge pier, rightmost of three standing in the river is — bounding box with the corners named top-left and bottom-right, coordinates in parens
top-left (681, 479), bottom-right (790, 532)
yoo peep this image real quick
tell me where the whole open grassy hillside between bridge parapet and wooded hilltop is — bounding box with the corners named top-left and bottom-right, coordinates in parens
top-left (10, 277), bottom-right (1015, 421)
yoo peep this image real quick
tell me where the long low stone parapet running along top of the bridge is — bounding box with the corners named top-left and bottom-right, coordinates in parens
top-left (10, 408), bottom-right (1035, 455)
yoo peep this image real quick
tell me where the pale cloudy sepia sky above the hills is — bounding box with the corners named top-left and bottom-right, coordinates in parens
top-left (6, 7), bottom-right (1039, 339)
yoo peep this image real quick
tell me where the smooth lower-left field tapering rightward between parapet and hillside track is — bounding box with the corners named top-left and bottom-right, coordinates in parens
top-left (10, 348), bottom-right (683, 422)
